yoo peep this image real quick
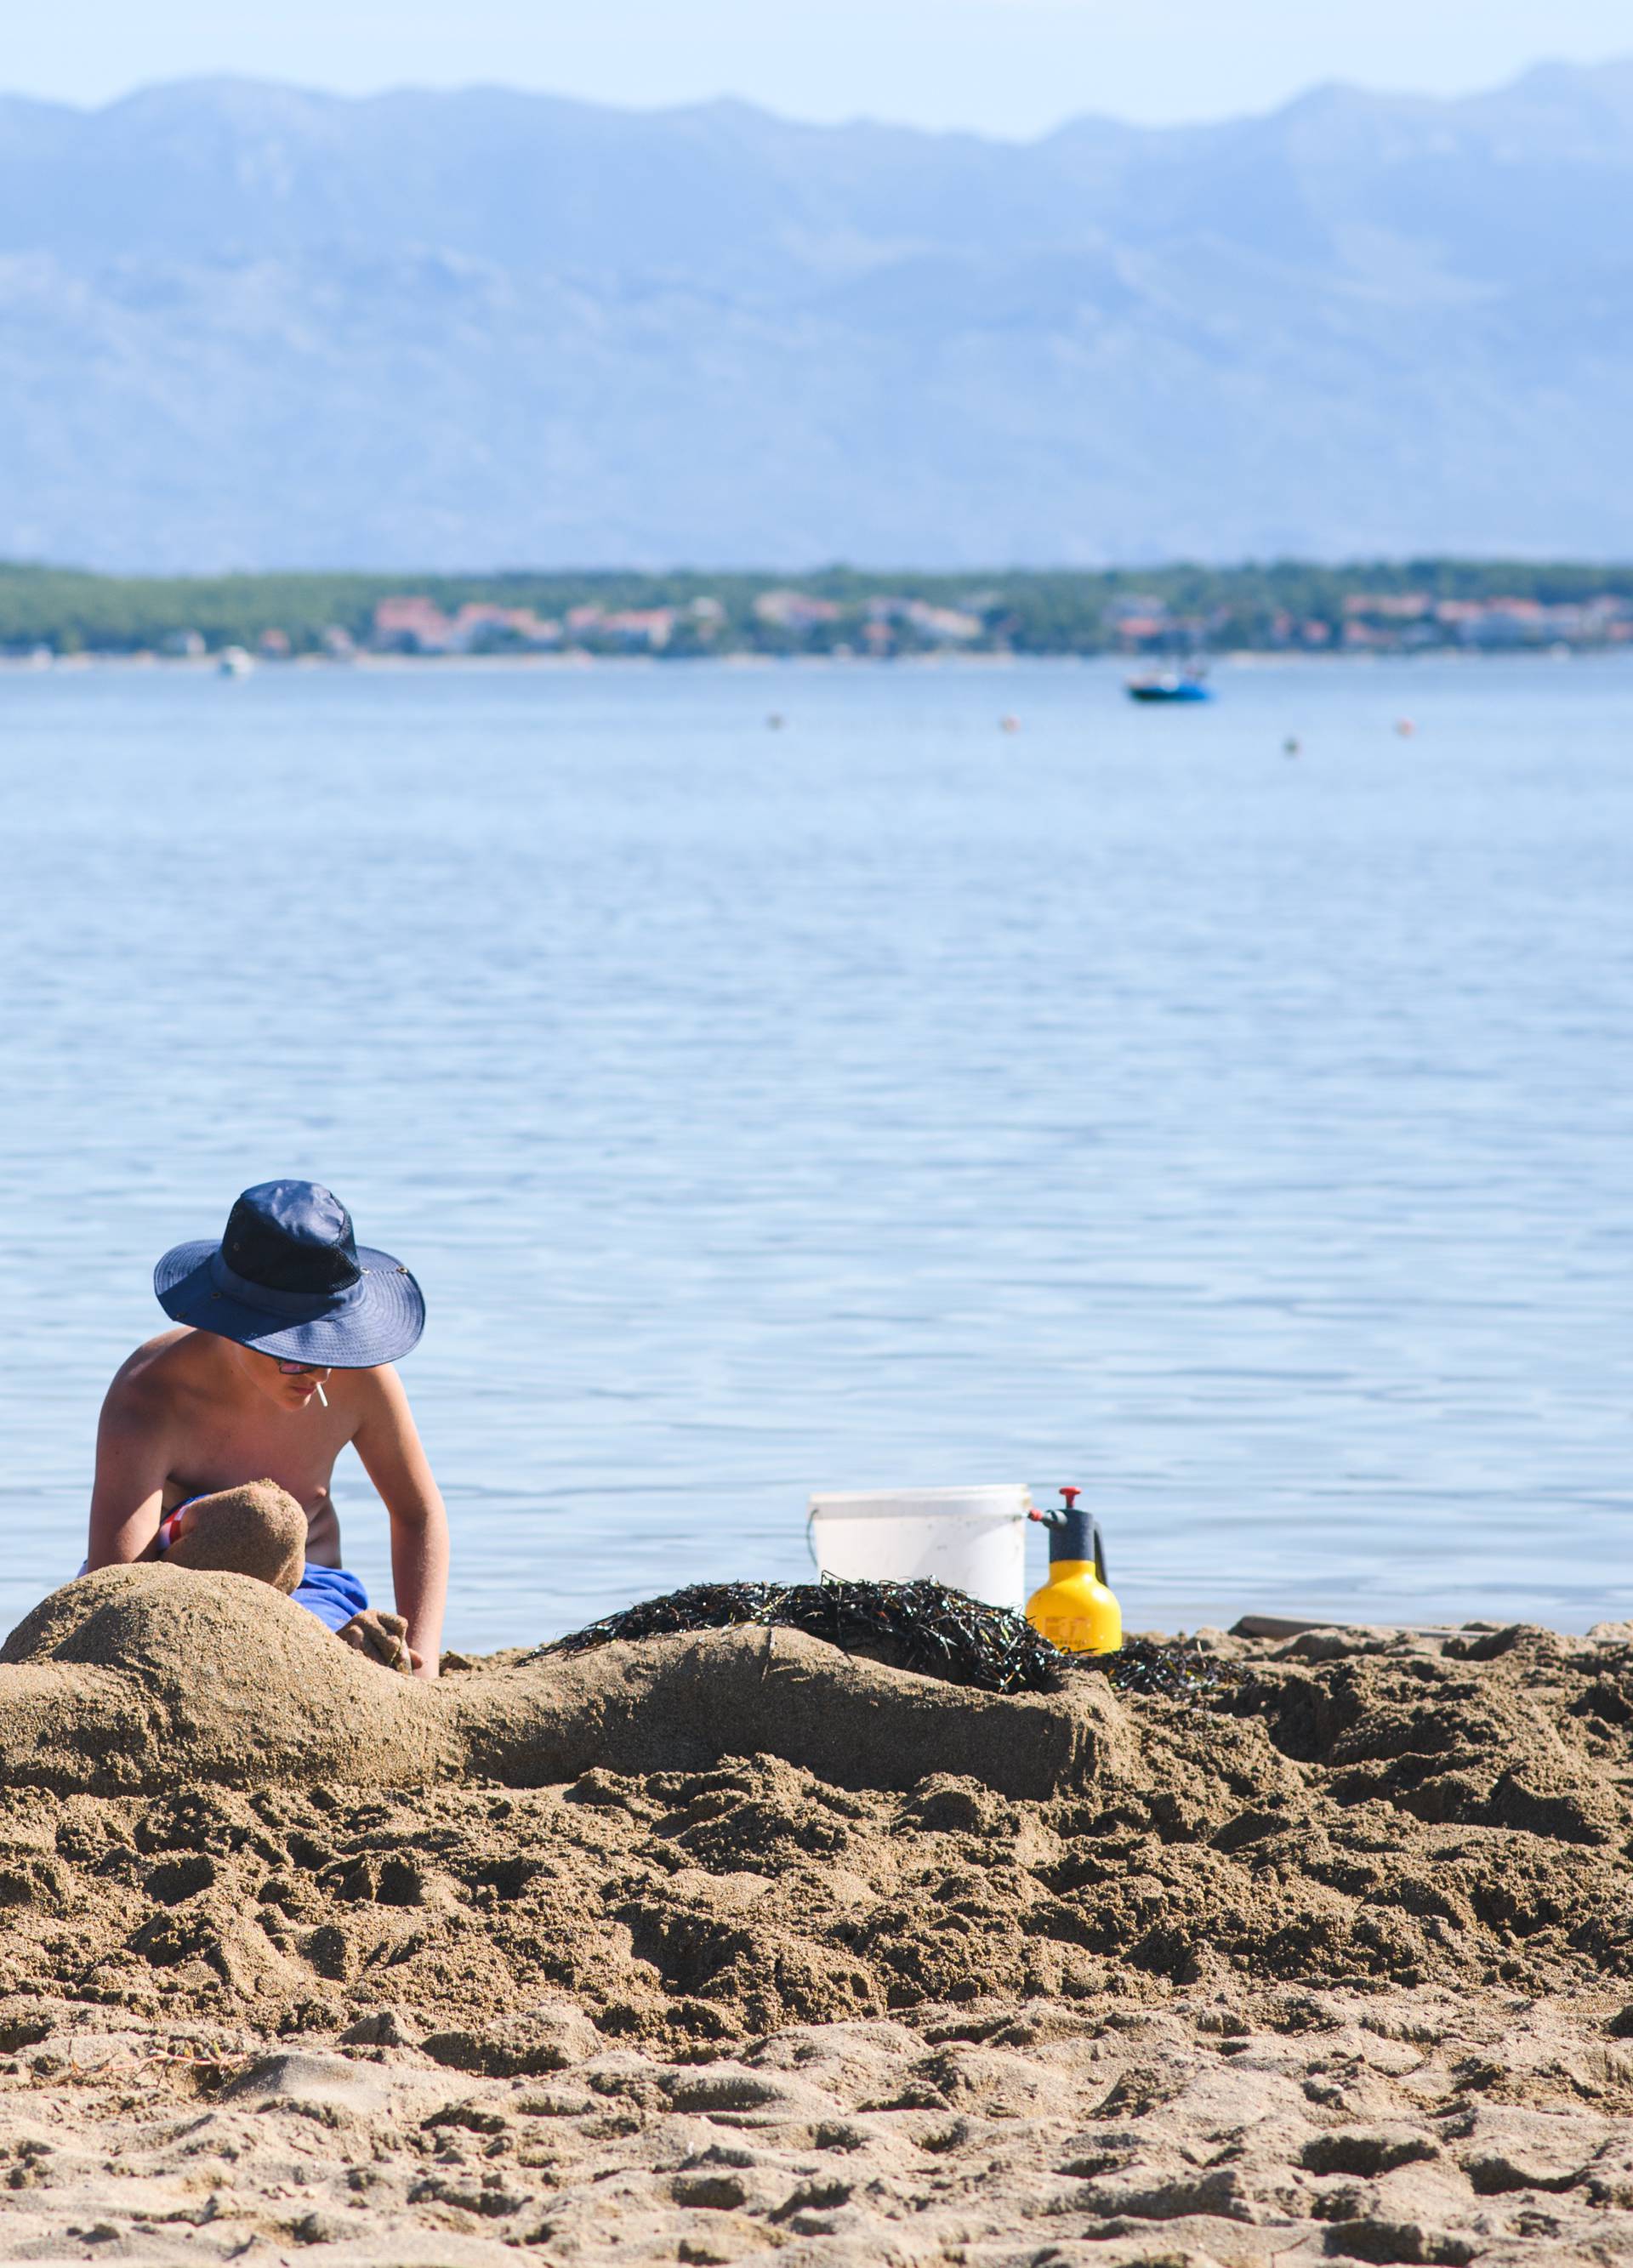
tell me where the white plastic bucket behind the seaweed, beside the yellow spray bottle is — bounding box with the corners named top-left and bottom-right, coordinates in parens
top-left (807, 1483), bottom-right (1032, 1612)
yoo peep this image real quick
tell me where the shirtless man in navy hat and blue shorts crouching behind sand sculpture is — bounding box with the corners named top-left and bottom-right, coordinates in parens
top-left (86, 1182), bottom-right (449, 1679)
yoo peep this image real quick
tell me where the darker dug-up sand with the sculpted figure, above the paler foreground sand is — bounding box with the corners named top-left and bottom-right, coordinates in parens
top-left (0, 1570), bottom-right (1633, 2041)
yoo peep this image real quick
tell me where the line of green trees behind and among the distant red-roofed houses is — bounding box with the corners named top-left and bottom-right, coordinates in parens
top-left (0, 558), bottom-right (1633, 653)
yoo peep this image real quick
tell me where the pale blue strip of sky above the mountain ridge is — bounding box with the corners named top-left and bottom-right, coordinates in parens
top-left (0, 0), bottom-right (1633, 134)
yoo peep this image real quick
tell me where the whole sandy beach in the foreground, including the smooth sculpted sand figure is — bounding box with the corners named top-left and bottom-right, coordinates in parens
top-left (0, 1567), bottom-right (1633, 2268)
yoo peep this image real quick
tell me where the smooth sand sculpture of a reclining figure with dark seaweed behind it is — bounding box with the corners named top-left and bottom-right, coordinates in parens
top-left (0, 1567), bottom-right (1116, 1796)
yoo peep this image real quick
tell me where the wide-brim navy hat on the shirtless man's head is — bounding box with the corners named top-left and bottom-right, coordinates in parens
top-left (154, 1182), bottom-right (424, 1370)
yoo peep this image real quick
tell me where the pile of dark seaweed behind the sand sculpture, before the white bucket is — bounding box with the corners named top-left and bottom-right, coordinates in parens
top-left (542, 1578), bottom-right (1225, 1703)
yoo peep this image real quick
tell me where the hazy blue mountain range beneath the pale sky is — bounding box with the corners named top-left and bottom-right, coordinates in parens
top-left (0, 61), bottom-right (1633, 569)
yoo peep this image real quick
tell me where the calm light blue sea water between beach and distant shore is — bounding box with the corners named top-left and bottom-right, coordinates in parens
top-left (0, 662), bottom-right (1633, 1646)
